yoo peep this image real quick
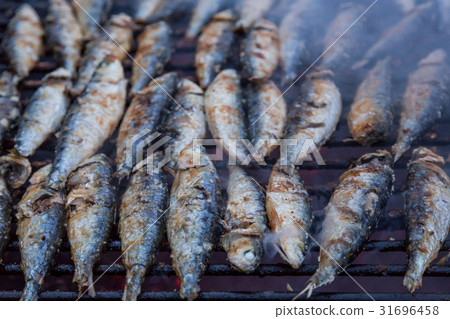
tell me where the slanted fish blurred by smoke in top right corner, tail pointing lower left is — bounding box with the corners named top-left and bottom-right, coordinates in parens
top-left (353, 1), bottom-right (434, 69)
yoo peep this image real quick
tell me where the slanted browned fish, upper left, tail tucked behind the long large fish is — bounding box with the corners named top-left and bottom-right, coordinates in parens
top-left (71, 13), bottom-right (133, 96)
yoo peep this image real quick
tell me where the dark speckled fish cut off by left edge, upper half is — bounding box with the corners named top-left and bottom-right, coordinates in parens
top-left (0, 71), bottom-right (21, 146)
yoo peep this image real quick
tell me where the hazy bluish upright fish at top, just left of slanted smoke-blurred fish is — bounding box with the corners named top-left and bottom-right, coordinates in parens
top-left (321, 3), bottom-right (368, 71)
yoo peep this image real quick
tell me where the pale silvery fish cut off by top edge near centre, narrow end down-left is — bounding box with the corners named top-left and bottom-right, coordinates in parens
top-left (186, 0), bottom-right (227, 39)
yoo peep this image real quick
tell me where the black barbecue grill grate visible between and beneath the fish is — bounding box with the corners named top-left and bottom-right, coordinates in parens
top-left (0, 0), bottom-right (450, 300)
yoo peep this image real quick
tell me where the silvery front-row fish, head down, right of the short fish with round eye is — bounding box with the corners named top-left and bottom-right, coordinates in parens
top-left (266, 162), bottom-right (313, 269)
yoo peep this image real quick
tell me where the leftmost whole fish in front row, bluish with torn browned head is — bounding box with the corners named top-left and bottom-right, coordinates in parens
top-left (17, 165), bottom-right (65, 301)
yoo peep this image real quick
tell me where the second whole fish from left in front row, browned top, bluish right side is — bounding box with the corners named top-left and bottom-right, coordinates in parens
top-left (66, 154), bottom-right (115, 297)
